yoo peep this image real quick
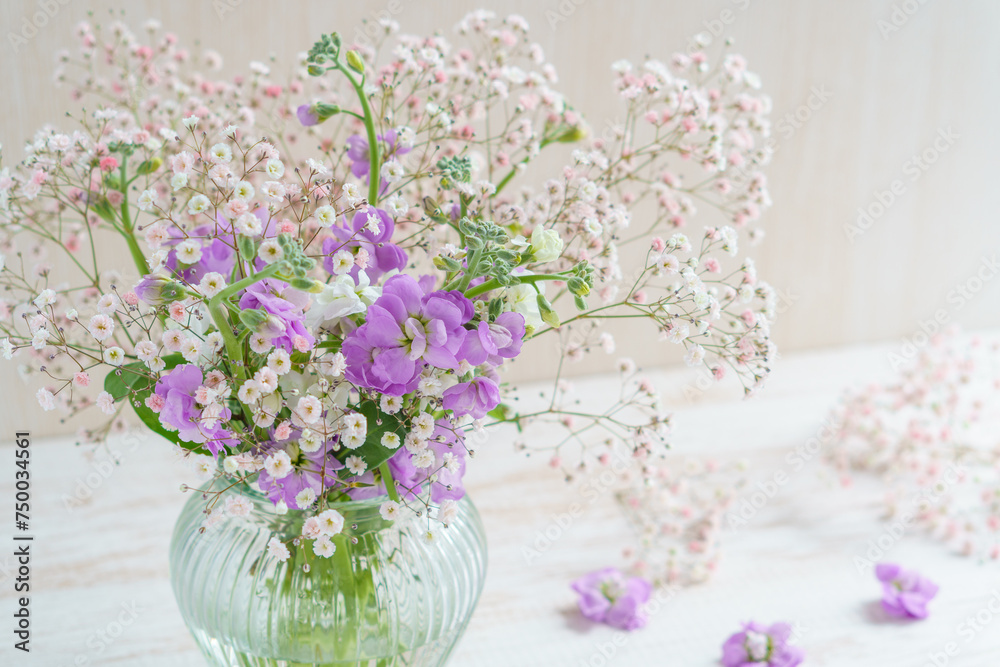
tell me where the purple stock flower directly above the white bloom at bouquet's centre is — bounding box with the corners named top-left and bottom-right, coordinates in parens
top-left (323, 207), bottom-right (409, 283)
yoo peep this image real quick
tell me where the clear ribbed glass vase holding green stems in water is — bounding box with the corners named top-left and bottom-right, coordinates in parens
top-left (170, 487), bottom-right (486, 667)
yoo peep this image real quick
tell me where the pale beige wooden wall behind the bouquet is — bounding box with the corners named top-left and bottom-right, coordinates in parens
top-left (0, 0), bottom-right (1000, 434)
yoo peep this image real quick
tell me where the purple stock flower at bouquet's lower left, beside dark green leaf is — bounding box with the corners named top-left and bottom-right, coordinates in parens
top-left (154, 364), bottom-right (237, 455)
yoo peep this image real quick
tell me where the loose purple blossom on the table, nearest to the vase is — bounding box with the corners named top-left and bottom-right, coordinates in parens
top-left (570, 567), bottom-right (653, 630)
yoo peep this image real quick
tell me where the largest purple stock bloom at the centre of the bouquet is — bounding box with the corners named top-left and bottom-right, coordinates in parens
top-left (342, 274), bottom-right (474, 396)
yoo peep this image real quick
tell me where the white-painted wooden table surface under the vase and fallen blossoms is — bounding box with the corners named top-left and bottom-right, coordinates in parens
top-left (0, 344), bottom-right (1000, 667)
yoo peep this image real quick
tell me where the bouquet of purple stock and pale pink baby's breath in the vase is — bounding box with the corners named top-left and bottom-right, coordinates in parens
top-left (0, 12), bottom-right (775, 559)
